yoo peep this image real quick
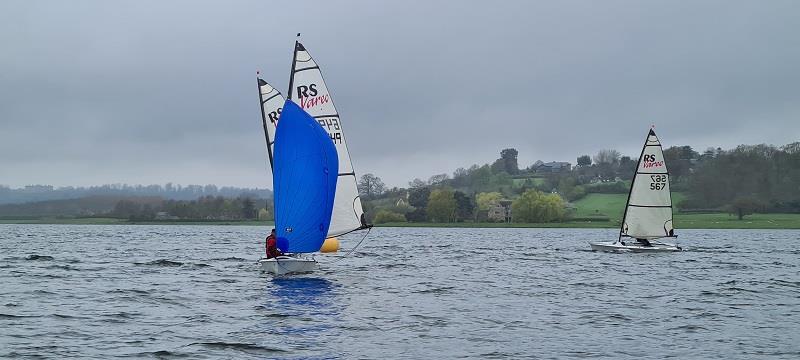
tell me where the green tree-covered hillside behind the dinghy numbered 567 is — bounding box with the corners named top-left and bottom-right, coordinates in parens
top-left (359, 143), bottom-right (800, 223)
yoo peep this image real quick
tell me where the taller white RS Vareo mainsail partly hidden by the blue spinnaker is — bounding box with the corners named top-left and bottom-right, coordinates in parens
top-left (288, 41), bottom-right (368, 237)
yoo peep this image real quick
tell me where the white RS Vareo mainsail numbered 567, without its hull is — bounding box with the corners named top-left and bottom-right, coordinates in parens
top-left (620, 129), bottom-right (674, 240)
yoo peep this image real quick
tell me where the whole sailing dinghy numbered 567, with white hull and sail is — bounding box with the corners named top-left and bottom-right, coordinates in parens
top-left (589, 129), bottom-right (681, 252)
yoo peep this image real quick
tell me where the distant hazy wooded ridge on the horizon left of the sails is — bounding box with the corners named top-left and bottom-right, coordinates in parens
top-left (0, 183), bottom-right (272, 204)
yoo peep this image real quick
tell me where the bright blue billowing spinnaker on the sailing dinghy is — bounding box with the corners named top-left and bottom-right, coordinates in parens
top-left (272, 101), bottom-right (339, 253)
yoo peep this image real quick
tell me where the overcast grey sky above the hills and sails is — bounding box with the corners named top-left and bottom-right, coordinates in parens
top-left (0, 0), bottom-right (800, 187)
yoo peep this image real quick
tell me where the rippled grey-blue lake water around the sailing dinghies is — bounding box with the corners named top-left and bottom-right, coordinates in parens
top-left (0, 225), bottom-right (800, 359)
